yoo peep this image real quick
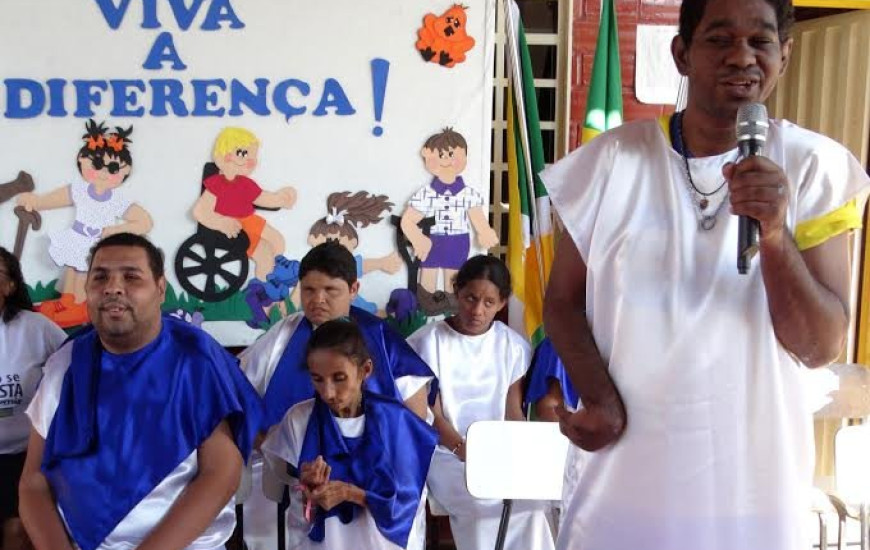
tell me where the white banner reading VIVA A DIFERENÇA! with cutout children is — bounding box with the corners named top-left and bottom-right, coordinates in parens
top-left (0, 0), bottom-right (495, 345)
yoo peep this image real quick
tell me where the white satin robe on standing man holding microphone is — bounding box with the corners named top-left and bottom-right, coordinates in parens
top-left (542, 117), bottom-right (868, 550)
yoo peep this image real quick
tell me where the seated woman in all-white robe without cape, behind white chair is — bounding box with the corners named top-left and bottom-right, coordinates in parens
top-left (408, 256), bottom-right (553, 550)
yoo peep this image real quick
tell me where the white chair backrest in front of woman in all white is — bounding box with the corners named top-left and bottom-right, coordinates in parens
top-left (465, 420), bottom-right (570, 500)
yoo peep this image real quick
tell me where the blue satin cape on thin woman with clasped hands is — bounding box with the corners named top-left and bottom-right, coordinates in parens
top-left (300, 390), bottom-right (438, 548)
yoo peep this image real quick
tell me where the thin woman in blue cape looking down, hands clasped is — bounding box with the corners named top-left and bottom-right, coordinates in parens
top-left (262, 319), bottom-right (437, 550)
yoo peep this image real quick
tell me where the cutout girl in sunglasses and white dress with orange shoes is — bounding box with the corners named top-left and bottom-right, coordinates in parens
top-left (18, 120), bottom-right (153, 327)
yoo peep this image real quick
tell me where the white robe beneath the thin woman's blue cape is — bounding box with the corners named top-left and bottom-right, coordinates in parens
top-left (262, 399), bottom-right (426, 550)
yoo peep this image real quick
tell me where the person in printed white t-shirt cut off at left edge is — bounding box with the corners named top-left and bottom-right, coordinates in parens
top-left (0, 247), bottom-right (66, 550)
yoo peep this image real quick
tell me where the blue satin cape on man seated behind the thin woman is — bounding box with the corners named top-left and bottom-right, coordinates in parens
top-left (262, 307), bottom-right (438, 431)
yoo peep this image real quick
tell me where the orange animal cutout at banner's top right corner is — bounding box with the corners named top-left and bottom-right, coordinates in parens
top-left (415, 4), bottom-right (474, 67)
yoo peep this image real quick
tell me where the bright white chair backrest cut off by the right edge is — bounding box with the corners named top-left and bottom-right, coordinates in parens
top-left (834, 424), bottom-right (870, 504)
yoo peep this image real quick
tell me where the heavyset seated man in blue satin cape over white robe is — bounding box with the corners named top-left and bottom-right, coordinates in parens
top-left (21, 233), bottom-right (262, 550)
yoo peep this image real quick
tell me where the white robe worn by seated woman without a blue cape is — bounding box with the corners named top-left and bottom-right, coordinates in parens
top-left (408, 321), bottom-right (553, 550)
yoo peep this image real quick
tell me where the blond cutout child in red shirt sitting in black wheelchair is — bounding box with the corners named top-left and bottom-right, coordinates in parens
top-left (175, 128), bottom-right (296, 302)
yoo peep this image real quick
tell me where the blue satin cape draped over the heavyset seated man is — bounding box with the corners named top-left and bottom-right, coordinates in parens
top-left (42, 316), bottom-right (262, 550)
